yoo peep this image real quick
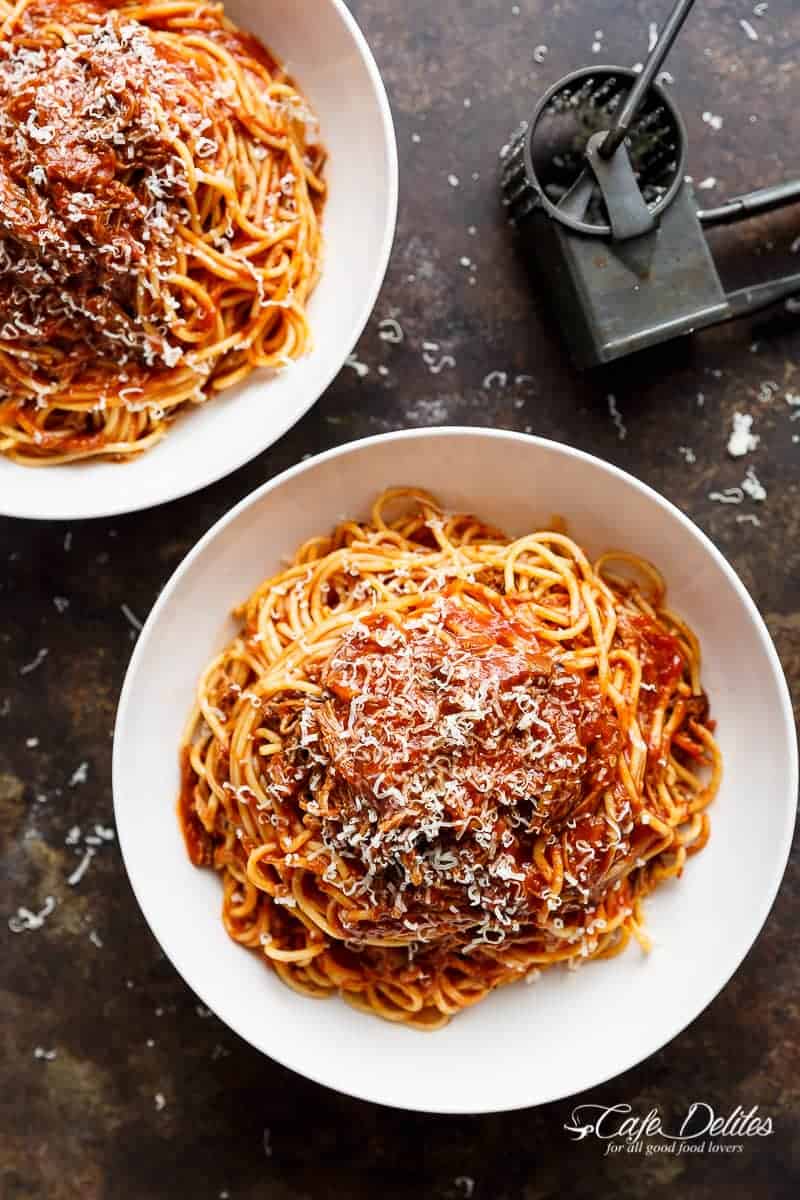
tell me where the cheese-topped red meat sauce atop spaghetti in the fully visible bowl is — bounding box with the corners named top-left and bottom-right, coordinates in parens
top-left (235, 600), bottom-right (646, 946)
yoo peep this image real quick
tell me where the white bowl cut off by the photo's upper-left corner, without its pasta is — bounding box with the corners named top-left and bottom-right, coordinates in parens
top-left (0, 0), bottom-right (397, 520)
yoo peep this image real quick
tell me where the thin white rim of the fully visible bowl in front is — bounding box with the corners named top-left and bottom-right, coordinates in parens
top-left (112, 425), bottom-right (799, 1116)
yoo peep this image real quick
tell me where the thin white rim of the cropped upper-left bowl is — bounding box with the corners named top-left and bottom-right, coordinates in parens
top-left (0, 0), bottom-right (399, 521)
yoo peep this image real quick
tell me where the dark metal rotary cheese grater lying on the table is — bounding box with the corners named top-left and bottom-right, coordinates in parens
top-left (501, 0), bottom-right (800, 367)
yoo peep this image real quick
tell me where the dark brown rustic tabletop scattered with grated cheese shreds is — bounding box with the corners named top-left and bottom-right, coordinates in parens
top-left (0, 0), bottom-right (800, 1200)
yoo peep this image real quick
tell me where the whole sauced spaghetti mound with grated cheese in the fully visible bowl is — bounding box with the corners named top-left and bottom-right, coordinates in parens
top-left (180, 488), bottom-right (721, 1028)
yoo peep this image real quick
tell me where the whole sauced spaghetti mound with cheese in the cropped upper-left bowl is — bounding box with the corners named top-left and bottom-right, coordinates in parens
top-left (0, 0), bottom-right (325, 466)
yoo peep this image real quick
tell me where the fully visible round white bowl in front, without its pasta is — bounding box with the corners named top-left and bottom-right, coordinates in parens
top-left (114, 428), bottom-right (798, 1112)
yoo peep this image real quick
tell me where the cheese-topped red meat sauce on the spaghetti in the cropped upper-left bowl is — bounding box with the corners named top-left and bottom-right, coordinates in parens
top-left (0, 0), bottom-right (204, 383)
